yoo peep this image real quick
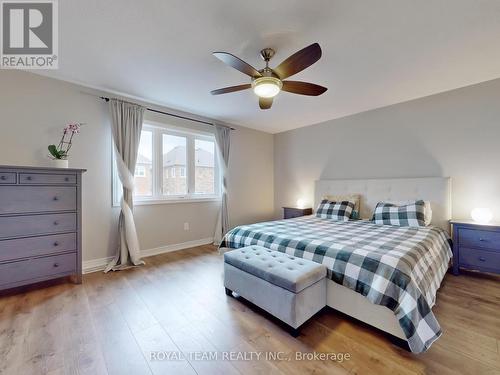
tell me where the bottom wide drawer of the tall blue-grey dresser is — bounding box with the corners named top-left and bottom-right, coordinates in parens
top-left (0, 253), bottom-right (77, 287)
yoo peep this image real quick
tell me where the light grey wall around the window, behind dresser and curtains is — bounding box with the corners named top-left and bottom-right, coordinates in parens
top-left (0, 70), bottom-right (274, 260)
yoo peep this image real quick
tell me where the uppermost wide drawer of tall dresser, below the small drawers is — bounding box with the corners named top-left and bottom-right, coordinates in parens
top-left (0, 186), bottom-right (76, 214)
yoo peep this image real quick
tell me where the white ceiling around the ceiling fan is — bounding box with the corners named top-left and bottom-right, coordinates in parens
top-left (38, 0), bottom-right (500, 133)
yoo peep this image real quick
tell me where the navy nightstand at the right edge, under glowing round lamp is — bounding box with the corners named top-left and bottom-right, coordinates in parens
top-left (451, 220), bottom-right (500, 275)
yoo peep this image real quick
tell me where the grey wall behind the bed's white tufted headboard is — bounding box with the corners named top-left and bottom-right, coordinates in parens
top-left (274, 80), bottom-right (500, 221)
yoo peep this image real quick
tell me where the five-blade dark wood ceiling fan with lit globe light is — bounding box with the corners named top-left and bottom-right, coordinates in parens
top-left (210, 43), bottom-right (328, 109)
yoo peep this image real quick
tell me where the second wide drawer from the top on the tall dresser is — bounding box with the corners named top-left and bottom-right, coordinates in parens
top-left (0, 213), bottom-right (77, 239)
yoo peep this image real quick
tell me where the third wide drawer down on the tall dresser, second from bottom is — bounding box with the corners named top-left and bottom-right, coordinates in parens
top-left (0, 233), bottom-right (76, 262)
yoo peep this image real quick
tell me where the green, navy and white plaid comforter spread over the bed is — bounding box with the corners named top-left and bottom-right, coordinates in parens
top-left (220, 216), bottom-right (452, 353)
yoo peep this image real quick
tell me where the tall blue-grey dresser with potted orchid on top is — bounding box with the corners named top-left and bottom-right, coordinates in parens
top-left (0, 166), bottom-right (85, 290)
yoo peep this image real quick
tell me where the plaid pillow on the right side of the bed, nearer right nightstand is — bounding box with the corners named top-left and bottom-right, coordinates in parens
top-left (372, 200), bottom-right (425, 227)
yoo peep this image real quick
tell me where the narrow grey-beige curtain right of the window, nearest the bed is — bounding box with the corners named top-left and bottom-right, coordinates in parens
top-left (214, 125), bottom-right (231, 245)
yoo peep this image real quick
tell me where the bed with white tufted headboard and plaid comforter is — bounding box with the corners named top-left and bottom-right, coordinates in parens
top-left (221, 178), bottom-right (451, 353)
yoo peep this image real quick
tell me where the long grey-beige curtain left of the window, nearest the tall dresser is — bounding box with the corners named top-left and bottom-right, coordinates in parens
top-left (104, 99), bottom-right (146, 272)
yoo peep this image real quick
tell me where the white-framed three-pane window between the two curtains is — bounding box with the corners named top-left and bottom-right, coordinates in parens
top-left (113, 124), bottom-right (220, 205)
